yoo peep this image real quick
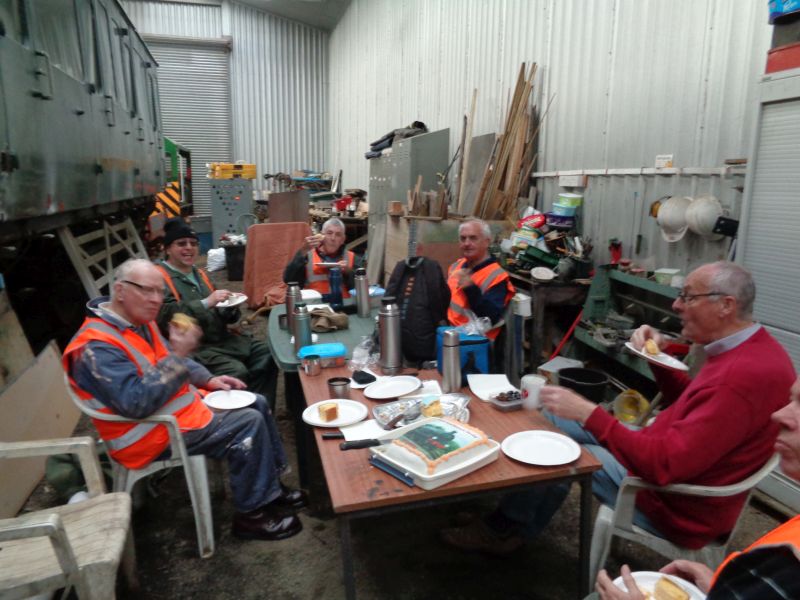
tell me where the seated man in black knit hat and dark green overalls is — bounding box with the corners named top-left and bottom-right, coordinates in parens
top-left (157, 219), bottom-right (278, 409)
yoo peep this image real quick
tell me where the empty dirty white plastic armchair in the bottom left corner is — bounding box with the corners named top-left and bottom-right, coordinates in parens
top-left (0, 437), bottom-right (138, 600)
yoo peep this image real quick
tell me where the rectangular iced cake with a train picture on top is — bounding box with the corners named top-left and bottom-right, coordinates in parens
top-left (381, 418), bottom-right (493, 475)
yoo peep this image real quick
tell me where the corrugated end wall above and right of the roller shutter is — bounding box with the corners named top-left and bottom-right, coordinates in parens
top-left (122, 0), bottom-right (328, 197)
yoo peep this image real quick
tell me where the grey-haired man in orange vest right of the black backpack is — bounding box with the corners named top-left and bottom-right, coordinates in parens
top-left (447, 219), bottom-right (516, 340)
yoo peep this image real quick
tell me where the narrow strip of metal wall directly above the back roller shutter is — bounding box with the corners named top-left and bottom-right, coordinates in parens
top-left (121, 0), bottom-right (222, 38)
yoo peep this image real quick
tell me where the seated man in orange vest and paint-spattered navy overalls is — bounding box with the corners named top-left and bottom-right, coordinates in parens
top-left (63, 259), bottom-right (307, 540)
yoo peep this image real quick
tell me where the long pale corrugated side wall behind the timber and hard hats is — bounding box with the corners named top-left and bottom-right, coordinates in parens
top-left (328, 0), bottom-right (771, 268)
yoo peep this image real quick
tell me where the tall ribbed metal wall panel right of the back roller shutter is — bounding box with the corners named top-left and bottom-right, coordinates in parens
top-left (229, 3), bottom-right (326, 188)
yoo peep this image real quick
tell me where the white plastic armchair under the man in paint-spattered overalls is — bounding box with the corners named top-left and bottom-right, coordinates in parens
top-left (64, 375), bottom-right (214, 558)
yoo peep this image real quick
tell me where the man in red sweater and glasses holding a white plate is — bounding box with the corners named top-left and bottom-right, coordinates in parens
top-left (443, 262), bottom-right (795, 553)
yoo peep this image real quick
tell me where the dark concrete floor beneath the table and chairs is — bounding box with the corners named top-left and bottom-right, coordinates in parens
top-left (29, 264), bottom-right (783, 600)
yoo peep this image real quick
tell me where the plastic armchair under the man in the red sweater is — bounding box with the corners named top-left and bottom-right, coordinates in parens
top-left (589, 454), bottom-right (780, 581)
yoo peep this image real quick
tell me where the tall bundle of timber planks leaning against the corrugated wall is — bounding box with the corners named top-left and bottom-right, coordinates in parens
top-left (472, 63), bottom-right (538, 220)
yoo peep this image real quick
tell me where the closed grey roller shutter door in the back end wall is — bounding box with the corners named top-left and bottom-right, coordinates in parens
top-left (147, 36), bottom-right (233, 216)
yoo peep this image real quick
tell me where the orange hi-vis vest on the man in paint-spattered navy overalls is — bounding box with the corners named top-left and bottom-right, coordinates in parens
top-left (63, 317), bottom-right (212, 469)
